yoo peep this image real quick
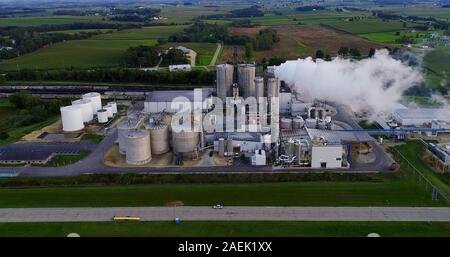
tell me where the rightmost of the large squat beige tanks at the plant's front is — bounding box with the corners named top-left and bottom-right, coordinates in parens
top-left (172, 125), bottom-right (199, 153)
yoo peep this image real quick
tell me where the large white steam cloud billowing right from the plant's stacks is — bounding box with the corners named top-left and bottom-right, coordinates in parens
top-left (275, 50), bottom-right (422, 113)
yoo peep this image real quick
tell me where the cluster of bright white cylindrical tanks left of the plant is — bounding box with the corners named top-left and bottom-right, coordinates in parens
top-left (61, 92), bottom-right (117, 132)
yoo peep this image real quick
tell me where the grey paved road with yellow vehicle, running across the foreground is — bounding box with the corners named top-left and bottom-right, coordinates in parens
top-left (0, 207), bottom-right (450, 222)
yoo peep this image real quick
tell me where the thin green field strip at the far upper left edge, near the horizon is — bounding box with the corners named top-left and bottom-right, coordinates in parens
top-left (0, 16), bottom-right (102, 27)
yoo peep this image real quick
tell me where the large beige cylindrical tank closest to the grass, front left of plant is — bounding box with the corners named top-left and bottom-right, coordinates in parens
top-left (125, 131), bottom-right (152, 165)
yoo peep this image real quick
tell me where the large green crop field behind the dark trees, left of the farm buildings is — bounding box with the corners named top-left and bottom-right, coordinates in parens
top-left (0, 25), bottom-right (190, 71)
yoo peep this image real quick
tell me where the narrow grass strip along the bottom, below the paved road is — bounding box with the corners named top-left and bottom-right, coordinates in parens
top-left (0, 221), bottom-right (450, 237)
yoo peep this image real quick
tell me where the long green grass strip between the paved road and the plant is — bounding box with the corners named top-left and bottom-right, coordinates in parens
top-left (0, 171), bottom-right (445, 208)
